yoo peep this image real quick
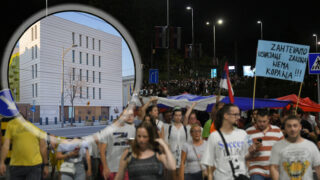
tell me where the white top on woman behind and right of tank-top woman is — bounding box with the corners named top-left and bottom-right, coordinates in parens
top-left (164, 124), bottom-right (192, 167)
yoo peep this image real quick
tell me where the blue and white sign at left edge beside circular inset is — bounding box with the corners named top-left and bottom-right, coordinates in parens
top-left (0, 89), bottom-right (19, 117)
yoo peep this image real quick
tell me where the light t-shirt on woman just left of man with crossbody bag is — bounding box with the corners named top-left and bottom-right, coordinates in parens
top-left (182, 141), bottom-right (207, 174)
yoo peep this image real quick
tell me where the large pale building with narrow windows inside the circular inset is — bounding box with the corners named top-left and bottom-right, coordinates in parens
top-left (19, 15), bottom-right (123, 121)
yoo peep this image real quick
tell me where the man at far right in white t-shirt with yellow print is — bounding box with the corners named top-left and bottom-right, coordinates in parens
top-left (270, 115), bottom-right (320, 180)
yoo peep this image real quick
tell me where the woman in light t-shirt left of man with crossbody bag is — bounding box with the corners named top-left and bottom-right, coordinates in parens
top-left (179, 124), bottom-right (207, 180)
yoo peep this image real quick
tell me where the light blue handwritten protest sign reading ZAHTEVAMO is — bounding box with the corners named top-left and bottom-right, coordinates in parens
top-left (256, 40), bottom-right (310, 82)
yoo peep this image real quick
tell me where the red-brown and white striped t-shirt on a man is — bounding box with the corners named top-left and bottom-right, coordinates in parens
top-left (246, 125), bottom-right (284, 177)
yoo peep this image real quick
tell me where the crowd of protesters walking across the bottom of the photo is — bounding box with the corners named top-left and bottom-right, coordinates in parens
top-left (0, 93), bottom-right (320, 180)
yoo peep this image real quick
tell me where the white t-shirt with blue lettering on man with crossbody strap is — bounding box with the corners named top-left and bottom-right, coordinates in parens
top-left (201, 128), bottom-right (252, 180)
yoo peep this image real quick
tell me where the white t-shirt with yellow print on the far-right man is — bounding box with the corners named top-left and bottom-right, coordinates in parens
top-left (270, 139), bottom-right (320, 180)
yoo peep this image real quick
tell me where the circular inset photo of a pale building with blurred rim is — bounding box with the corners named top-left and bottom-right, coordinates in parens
top-left (1, 4), bottom-right (141, 137)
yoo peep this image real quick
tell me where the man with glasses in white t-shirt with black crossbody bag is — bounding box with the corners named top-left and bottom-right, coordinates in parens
top-left (201, 104), bottom-right (256, 180)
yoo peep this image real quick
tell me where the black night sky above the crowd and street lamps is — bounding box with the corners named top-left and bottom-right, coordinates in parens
top-left (0, 0), bottom-right (320, 81)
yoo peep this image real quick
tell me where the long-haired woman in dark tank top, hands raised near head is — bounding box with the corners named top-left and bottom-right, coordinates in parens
top-left (115, 122), bottom-right (176, 180)
